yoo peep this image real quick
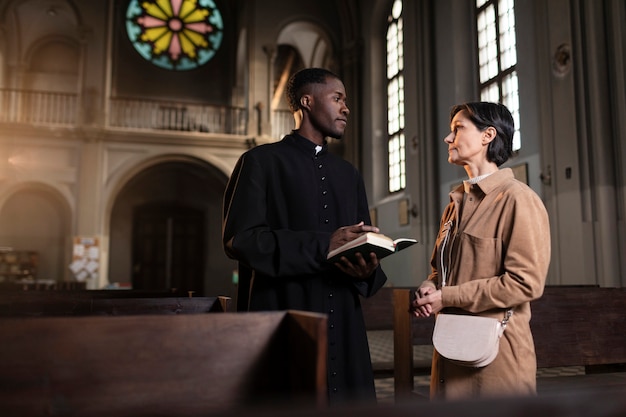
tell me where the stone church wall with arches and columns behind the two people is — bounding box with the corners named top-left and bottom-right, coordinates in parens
top-left (0, 0), bottom-right (626, 288)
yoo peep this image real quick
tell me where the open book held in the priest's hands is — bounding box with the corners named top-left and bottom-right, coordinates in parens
top-left (327, 232), bottom-right (417, 262)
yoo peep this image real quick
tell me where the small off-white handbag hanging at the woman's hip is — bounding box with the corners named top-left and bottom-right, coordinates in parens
top-left (433, 310), bottom-right (512, 368)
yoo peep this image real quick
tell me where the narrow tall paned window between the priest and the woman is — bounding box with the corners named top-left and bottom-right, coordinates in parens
top-left (387, 0), bottom-right (406, 193)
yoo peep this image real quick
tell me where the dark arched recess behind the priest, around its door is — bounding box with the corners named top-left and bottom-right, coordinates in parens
top-left (105, 154), bottom-right (235, 297)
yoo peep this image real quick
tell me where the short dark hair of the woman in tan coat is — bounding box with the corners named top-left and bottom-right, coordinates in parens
top-left (450, 101), bottom-right (515, 166)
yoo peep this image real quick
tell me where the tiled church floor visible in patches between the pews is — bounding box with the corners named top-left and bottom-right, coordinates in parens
top-left (367, 330), bottom-right (585, 403)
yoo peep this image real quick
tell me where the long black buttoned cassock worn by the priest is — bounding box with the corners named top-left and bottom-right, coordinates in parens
top-left (223, 133), bottom-right (387, 404)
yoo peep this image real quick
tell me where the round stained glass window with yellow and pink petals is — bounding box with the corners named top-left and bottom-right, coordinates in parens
top-left (126, 0), bottom-right (224, 71)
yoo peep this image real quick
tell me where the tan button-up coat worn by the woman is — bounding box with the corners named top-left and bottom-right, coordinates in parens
top-left (422, 168), bottom-right (550, 399)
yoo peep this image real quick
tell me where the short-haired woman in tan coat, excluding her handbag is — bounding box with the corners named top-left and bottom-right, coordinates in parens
top-left (411, 102), bottom-right (550, 400)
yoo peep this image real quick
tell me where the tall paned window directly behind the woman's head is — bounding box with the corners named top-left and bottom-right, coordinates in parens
top-left (476, 0), bottom-right (522, 151)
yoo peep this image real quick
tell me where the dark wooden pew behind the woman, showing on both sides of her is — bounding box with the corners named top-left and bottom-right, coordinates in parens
top-left (393, 286), bottom-right (626, 399)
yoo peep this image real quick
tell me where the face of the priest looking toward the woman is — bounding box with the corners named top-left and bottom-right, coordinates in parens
top-left (309, 77), bottom-right (350, 139)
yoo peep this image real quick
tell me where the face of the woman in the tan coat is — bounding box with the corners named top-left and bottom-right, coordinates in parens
top-left (443, 110), bottom-right (491, 166)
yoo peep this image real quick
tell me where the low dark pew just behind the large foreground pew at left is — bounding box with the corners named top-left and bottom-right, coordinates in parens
top-left (0, 290), bottom-right (230, 317)
